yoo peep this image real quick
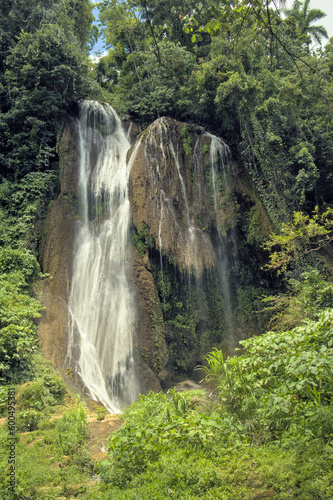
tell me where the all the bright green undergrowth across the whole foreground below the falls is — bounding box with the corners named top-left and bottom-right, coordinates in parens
top-left (0, 309), bottom-right (333, 500)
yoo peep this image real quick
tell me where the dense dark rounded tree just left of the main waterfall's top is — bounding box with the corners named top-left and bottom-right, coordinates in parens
top-left (0, 24), bottom-right (92, 177)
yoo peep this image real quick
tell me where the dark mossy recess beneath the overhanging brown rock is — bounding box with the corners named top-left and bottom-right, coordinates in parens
top-left (151, 250), bottom-right (223, 376)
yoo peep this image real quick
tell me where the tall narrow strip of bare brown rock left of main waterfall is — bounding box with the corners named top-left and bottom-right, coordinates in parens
top-left (38, 119), bottom-right (78, 368)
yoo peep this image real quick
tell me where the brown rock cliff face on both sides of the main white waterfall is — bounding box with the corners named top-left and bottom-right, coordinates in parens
top-left (39, 102), bottom-right (269, 406)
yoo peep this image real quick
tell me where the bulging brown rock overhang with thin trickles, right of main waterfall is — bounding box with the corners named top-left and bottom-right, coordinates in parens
top-left (129, 118), bottom-right (215, 273)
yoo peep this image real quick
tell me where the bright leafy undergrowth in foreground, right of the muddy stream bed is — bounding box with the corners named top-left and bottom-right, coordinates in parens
top-left (86, 310), bottom-right (333, 500)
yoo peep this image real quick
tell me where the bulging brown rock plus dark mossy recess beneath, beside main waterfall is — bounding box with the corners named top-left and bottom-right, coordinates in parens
top-left (129, 118), bottom-right (241, 372)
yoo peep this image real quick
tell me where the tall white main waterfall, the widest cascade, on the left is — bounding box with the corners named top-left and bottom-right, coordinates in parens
top-left (67, 101), bottom-right (139, 413)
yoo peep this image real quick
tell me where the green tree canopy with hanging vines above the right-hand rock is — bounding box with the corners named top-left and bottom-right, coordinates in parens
top-left (95, 0), bottom-right (333, 225)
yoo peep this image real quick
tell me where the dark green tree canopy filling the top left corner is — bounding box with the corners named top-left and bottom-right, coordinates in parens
top-left (0, 0), bottom-right (98, 182)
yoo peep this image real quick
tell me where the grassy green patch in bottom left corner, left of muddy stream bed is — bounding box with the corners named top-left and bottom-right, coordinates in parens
top-left (0, 395), bottom-right (101, 500)
